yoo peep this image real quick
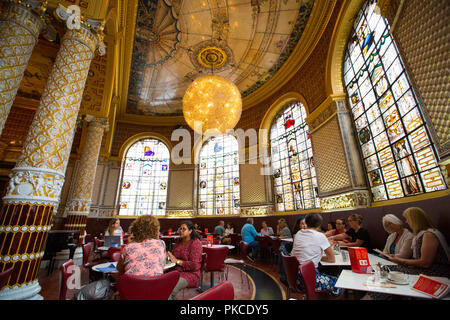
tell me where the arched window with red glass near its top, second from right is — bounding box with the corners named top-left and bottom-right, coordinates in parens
top-left (270, 102), bottom-right (320, 211)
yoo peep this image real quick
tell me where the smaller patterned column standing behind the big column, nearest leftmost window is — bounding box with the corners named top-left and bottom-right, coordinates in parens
top-left (64, 117), bottom-right (107, 247)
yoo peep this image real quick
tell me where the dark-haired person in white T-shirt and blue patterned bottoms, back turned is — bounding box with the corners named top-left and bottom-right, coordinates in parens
top-left (291, 213), bottom-right (342, 295)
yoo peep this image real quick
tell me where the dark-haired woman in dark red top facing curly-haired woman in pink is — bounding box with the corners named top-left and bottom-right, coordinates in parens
top-left (167, 221), bottom-right (203, 300)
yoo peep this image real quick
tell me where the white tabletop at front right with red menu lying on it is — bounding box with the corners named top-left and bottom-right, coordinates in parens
top-left (335, 270), bottom-right (450, 300)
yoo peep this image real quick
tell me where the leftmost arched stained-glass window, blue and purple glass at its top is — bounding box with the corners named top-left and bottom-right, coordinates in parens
top-left (119, 138), bottom-right (170, 216)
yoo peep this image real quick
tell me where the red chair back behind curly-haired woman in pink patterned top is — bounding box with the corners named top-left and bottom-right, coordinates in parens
top-left (117, 271), bottom-right (180, 300)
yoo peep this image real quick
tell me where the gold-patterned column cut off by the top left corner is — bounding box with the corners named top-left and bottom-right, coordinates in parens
top-left (0, 1), bottom-right (46, 134)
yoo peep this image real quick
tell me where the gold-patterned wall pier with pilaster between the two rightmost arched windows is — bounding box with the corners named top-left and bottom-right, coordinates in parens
top-left (306, 96), bottom-right (371, 210)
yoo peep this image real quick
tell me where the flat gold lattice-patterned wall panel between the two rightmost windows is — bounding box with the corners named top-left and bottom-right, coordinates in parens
top-left (311, 114), bottom-right (350, 196)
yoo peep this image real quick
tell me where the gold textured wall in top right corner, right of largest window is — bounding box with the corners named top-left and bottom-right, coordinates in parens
top-left (393, 0), bottom-right (450, 156)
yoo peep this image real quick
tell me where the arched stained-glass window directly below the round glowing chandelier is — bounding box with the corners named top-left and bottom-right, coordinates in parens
top-left (198, 135), bottom-right (241, 215)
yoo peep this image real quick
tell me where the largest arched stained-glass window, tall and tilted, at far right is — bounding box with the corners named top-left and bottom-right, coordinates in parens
top-left (344, 1), bottom-right (446, 201)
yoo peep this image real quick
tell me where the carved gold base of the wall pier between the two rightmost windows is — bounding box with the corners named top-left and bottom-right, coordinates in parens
top-left (320, 190), bottom-right (371, 211)
